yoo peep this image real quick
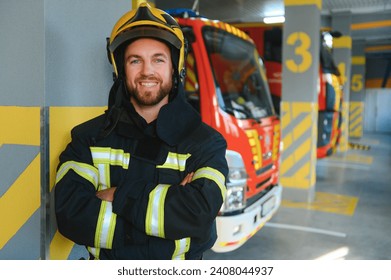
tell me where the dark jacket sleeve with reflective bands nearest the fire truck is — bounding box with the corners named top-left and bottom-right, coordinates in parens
top-left (113, 130), bottom-right (228, 241)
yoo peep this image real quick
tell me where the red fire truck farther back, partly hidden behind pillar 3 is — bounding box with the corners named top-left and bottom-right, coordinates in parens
top-left (235, 23), bottom-right (343, 158)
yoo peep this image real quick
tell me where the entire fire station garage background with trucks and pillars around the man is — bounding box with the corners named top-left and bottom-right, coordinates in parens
top-left (0, 0), bottom-right (391, 260)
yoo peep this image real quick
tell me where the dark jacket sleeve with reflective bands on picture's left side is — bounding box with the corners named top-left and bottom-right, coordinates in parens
top-left (54, 124), bottom-right (125, 249)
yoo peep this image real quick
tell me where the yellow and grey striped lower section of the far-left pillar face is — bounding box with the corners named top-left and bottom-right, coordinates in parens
top-left (0, 106), bottom-right (40, 259)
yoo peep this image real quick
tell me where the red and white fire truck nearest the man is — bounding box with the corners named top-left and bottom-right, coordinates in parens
top-left (168, 10), bottom-right (282, 252)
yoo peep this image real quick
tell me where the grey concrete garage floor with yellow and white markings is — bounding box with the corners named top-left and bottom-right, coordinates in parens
top-left (204, 134), bottom-right (391, 260)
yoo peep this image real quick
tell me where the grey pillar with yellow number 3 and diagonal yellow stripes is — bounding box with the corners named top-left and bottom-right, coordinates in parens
top-left (280, 0), bottom-right (322, 202)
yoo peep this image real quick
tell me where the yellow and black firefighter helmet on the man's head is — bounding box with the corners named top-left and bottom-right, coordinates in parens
top-left (107, 2), bottom-right (185, 77)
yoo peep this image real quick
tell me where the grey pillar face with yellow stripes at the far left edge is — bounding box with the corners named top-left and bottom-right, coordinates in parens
top-left (0, 0), bottom-right (45, 260)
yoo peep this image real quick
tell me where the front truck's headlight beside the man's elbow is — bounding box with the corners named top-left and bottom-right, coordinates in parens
top-left (221, 150), bottom-right (247, 213)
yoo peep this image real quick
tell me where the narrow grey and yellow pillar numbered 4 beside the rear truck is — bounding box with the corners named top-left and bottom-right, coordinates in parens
top-left (331, 12), bottom-right (352, 152)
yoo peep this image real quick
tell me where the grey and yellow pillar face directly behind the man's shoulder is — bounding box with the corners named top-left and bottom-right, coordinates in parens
top-left (42, 0), bottom-right (132, 259)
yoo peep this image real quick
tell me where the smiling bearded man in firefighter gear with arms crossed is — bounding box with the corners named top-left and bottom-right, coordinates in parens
top-left (55, 3), bottom-right (228, 259)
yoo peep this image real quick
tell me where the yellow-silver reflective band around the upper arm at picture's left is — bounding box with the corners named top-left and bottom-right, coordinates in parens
top-left (56, 161), bottom-right (99, 189)
